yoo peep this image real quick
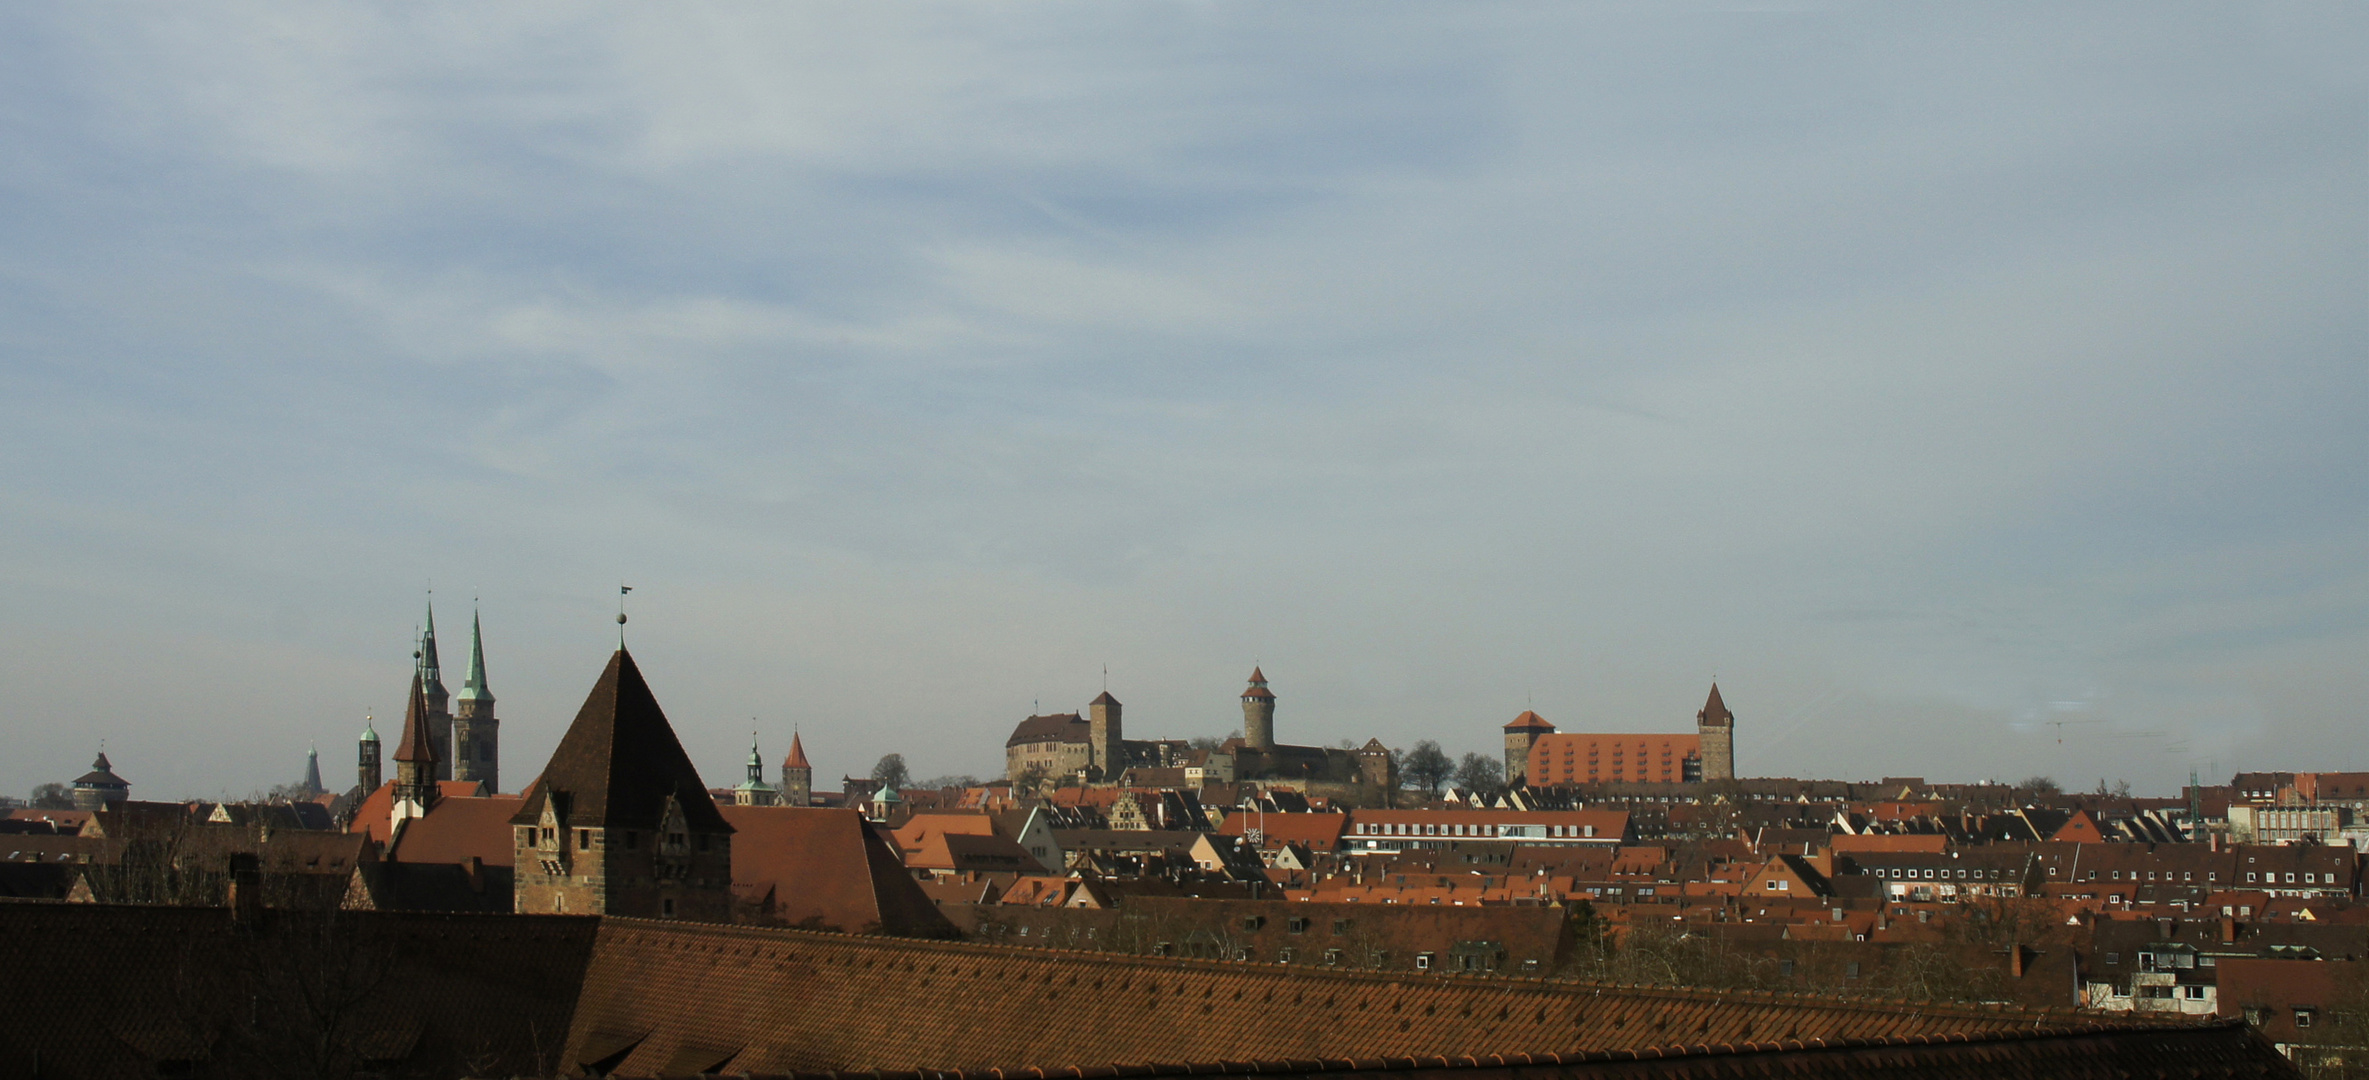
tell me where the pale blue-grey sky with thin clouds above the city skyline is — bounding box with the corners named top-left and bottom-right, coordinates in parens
top-left (0, 2), bottom-right (2369, 798)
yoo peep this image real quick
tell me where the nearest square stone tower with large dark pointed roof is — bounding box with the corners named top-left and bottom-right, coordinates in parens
top-left (509, 649), bottom-right (732, 921)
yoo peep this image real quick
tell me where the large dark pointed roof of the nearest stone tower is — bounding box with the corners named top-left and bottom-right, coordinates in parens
top-left (512, 649), bottom-right (732, 834)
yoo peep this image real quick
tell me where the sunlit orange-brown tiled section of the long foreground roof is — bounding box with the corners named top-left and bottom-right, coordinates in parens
top-left (569, 919), bottom-right (2226, 1075)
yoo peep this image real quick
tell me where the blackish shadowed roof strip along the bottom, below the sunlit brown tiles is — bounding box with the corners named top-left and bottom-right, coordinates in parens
top-left (672, 1023), bottom-right (2298, 1080)
